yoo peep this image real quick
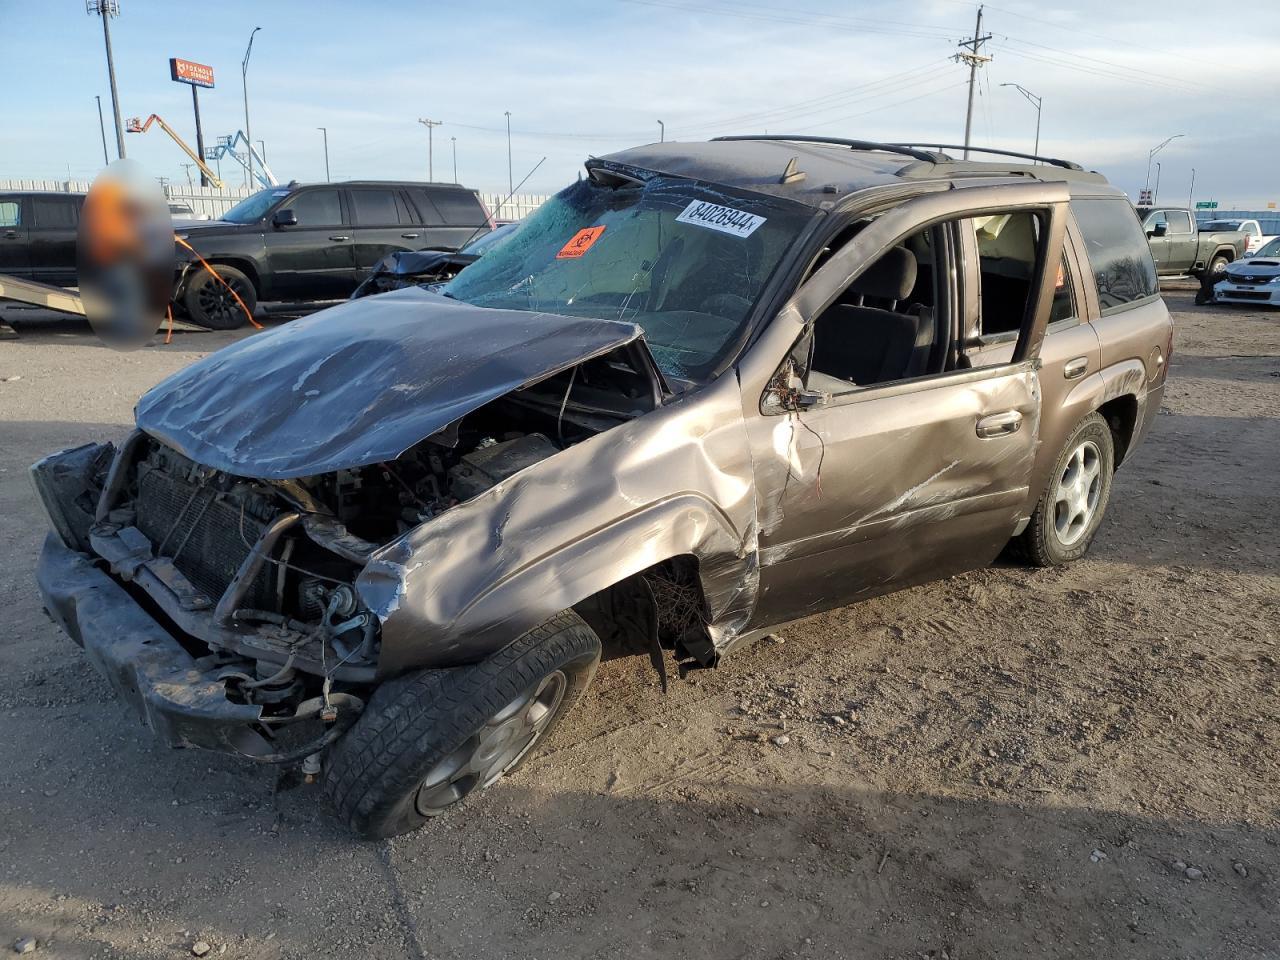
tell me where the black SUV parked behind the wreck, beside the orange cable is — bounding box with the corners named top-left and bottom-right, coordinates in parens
top-left (173, 180), bottom-right (492, 329)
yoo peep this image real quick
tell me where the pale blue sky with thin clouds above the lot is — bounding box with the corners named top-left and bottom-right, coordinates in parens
top-left (0, 0), bottom-right (1280, 209)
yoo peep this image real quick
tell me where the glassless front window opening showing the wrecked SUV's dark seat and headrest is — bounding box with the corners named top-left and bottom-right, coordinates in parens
top-left (808, 227), bottom-right (950, 393)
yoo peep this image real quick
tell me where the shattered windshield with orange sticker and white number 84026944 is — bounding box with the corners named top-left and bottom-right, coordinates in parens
top-left (442, 177), bottom-right (813, 380)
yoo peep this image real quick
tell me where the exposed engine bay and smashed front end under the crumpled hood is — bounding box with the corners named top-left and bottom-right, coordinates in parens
top-left (80, 355), bottom-right (652, 703)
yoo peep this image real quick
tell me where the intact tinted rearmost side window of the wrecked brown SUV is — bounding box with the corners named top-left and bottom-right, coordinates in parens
top-left (1071, 197), bottom-right (1160, 316)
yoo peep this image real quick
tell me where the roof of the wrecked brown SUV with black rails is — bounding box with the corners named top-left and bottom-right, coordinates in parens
top-left (600, 134), bottom-right (1114, 207)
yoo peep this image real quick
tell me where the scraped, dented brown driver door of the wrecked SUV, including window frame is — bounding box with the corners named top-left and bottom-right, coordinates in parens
top-left (742, 183), bottom-right (1068, 628)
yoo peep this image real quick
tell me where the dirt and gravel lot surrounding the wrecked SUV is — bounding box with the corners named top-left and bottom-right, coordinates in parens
top-left (0, 291), bottom-right (1280, 960)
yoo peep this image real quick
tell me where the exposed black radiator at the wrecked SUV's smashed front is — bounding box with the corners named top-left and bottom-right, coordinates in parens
top-left (137, 466), bottom-right (275, 609)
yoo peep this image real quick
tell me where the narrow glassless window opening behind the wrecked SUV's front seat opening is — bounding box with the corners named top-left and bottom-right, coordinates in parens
top-left (972, 212), bottom-right (1039, 337)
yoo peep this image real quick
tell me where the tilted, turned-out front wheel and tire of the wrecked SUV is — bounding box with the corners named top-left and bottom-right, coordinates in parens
top-left (325, 611), bottom-right (600, 840)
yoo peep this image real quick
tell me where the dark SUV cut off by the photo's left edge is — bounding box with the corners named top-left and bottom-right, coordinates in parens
top-left (0, 191), bottom-right (84, 287)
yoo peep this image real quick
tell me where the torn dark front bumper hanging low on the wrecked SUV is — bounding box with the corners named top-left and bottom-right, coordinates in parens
top-left (36, 534), bottom-right (271, 758)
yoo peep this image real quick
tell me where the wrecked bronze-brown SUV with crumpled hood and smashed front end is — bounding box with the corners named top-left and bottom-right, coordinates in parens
top-left (32, 137), bottom-right (1171, 836)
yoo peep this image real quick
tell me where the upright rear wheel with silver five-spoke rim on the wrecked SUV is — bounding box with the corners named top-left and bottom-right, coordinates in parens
top-left (1016, 413), bottom-right (1115, 567)
